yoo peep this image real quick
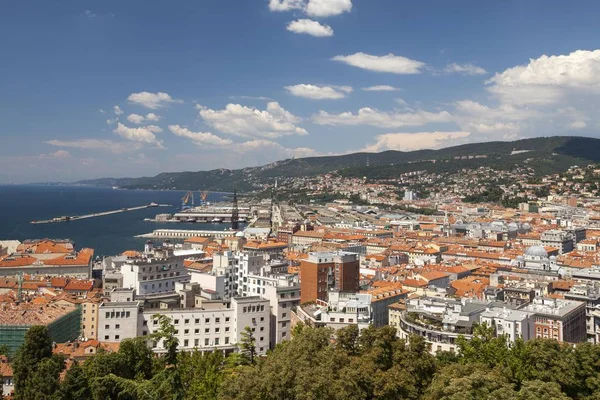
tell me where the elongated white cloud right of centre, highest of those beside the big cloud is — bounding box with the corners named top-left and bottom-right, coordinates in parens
top-left (332, 53), bottom-right (425, 74)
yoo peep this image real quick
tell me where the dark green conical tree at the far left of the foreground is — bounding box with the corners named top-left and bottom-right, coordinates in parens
top-left (13, 325), bottom-right (62, 400)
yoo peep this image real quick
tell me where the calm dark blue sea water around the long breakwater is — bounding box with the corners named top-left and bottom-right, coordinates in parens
top-left (0, 185), bottom-right (228, 255)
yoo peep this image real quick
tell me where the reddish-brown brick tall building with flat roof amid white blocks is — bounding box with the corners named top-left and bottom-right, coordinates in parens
top-left (300, 251), bottom-right (360, 303)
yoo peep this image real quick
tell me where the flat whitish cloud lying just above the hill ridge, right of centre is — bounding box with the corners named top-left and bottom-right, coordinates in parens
top-left (363, 131), bottom-right (470, 152)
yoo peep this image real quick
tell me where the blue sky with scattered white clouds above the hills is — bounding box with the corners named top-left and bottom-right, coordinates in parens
top-left (0, 0), bottom-right (600, 183)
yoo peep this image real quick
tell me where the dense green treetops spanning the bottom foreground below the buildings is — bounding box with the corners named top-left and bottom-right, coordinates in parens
top-left (14, 319), bottom-right (600, 400)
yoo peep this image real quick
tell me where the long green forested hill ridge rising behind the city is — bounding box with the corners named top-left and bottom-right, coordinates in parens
top-left (77, 136), bottom-right (600, 191)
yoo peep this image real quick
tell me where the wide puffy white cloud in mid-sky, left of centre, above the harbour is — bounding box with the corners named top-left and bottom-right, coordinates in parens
top-left (199, 101), bottom-right (308, 138)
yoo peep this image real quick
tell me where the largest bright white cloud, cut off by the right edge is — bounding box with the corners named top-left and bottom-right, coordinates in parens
top-left (486, 50), bottom-right (600, 105)
